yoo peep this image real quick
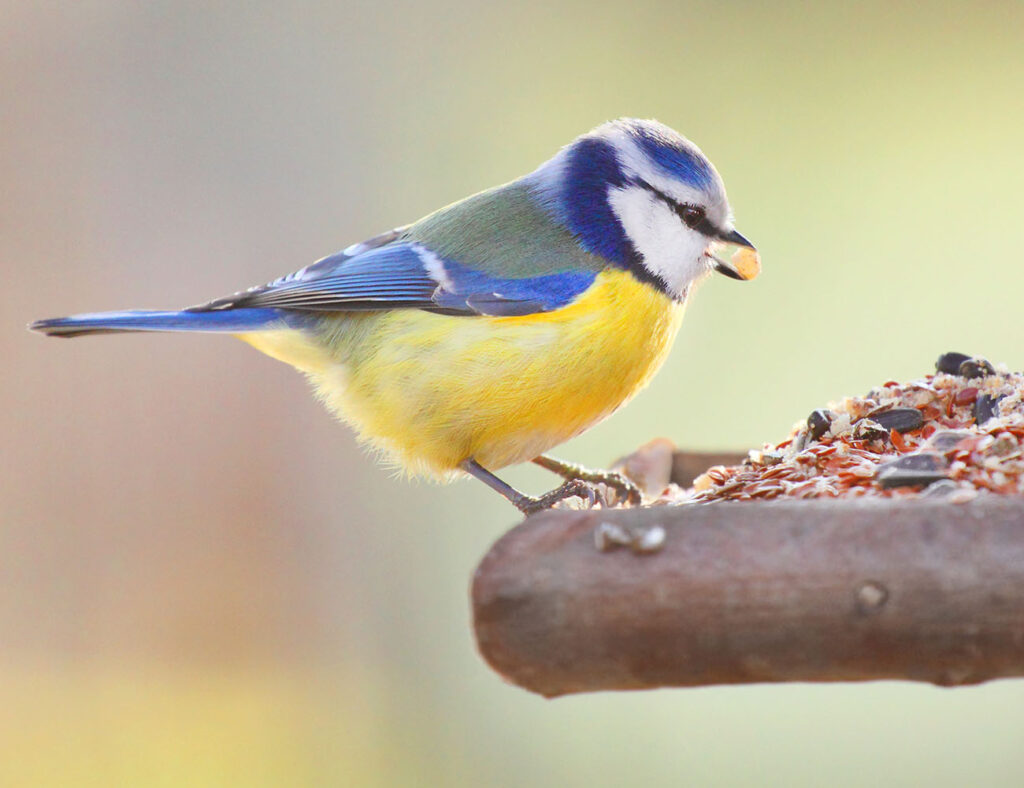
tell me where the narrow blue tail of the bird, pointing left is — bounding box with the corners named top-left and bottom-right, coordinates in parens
top-left (29, 307), bottom-right (296, 337)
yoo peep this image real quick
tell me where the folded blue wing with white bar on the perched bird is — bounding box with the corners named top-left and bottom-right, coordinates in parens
top-left (193, 230), bottom-right (597, 315)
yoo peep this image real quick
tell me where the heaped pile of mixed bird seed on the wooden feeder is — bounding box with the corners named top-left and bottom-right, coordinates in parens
top-left (654, 353), bottom-right (1024, 504)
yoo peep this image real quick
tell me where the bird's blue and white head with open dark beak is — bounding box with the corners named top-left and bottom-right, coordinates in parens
top-left (531, 119), bottom-right (754, 299)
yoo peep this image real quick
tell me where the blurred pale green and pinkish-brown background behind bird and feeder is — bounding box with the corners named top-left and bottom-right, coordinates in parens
top-left (6, 0), bottom-right (1024, 786)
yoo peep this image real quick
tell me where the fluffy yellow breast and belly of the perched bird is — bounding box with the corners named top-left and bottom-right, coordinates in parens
top-left (236, 271), bottom-right (682, 476)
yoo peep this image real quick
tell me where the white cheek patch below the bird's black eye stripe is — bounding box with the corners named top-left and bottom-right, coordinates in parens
top-left (608, 186), bottom-right (709, 298)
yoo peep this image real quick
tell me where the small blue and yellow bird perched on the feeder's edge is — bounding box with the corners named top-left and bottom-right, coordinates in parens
top-left (29, 118), bottom-right (760, 514)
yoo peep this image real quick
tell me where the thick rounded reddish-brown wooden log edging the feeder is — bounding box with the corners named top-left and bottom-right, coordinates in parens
top-left (472, 494), bottom-right (1024, 697)
